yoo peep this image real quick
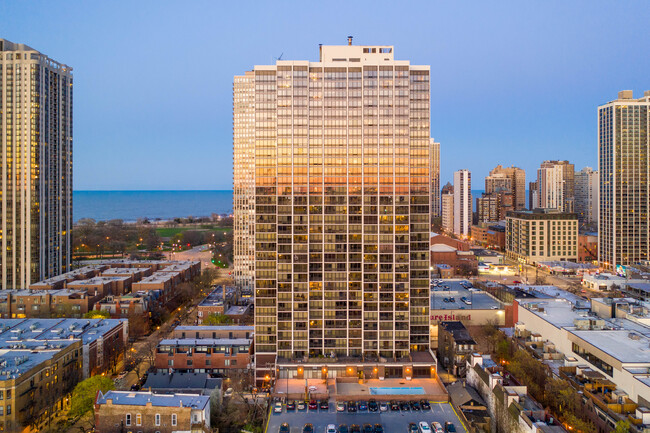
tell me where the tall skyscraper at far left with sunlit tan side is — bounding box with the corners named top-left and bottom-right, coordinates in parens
top-left (0, 39), bottom-right (72, 289)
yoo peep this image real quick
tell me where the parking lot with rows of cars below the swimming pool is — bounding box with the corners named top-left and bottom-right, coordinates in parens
top-left (267, 402), bottom-right (467, 433)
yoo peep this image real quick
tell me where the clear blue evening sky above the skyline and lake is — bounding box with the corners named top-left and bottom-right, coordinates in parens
top-left (0, 0), bottom-right (650, 190)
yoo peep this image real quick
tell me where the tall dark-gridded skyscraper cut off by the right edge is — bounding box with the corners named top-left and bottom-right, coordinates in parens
top-left (598, 90), bottom-right (650, 271)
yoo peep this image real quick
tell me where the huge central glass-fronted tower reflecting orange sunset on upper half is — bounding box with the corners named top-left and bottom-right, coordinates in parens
top-left (235, 43), bottom-right (432, 380)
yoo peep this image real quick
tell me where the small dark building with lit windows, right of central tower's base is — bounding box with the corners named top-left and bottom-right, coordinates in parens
top-left (438, 320), bottom-right (476, 377)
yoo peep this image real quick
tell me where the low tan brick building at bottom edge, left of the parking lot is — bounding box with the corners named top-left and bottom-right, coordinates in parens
top-left (95, 391), bottom-right (212, 433)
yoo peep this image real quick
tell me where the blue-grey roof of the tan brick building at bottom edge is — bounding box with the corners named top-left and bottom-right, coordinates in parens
top-left (96, 391), bottom-right (210, 409)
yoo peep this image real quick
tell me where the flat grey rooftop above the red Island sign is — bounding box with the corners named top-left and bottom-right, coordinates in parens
top-left (431, 280), bottom-right (502, 310)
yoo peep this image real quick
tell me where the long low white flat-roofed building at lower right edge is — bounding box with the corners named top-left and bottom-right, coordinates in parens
top-left (516, 298), bottom-right (650, 431)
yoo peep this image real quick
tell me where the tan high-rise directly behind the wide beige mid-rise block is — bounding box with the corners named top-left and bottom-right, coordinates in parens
top-left (534, 161), bottom-right (575, 212)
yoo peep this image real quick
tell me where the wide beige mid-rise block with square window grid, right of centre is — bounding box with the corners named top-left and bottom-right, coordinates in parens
top-left (506, 209), bottom-right (578, 263)
